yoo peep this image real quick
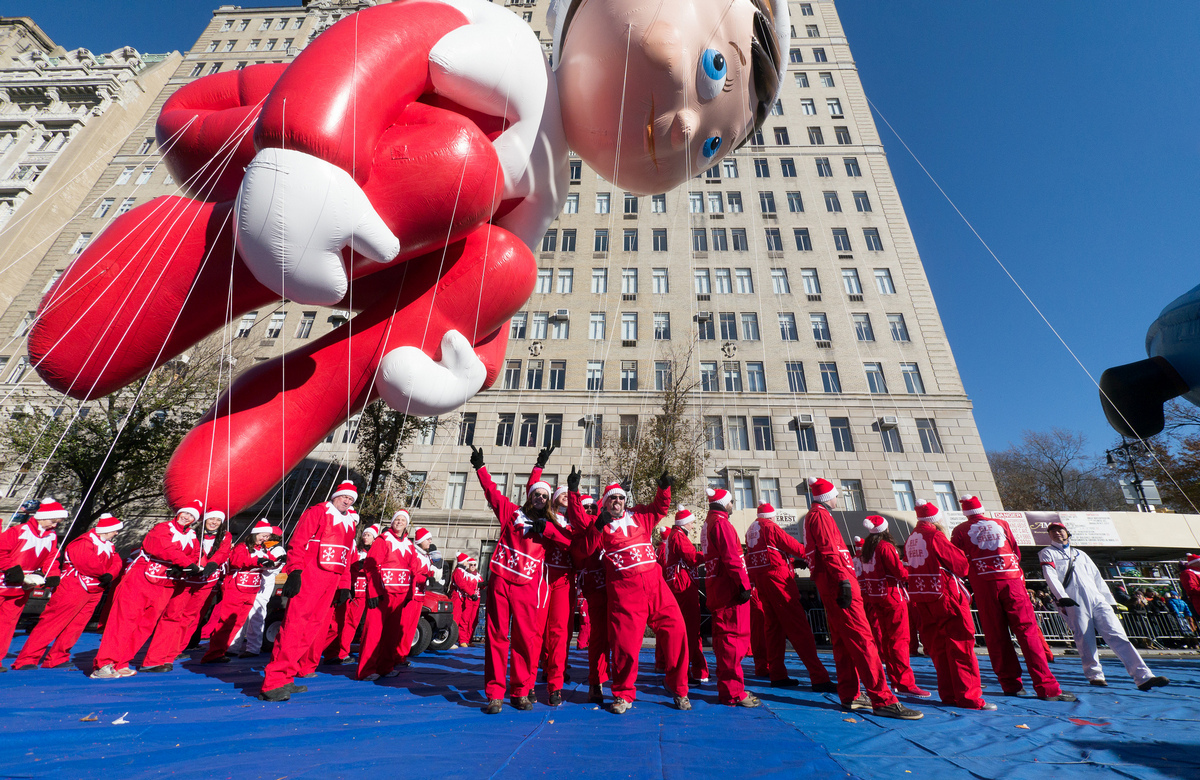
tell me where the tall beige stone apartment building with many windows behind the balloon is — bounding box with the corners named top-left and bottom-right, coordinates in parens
top-left (0, 0), bottom-right (1000, 552)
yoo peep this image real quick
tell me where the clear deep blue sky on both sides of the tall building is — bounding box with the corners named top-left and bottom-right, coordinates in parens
top-left (4, 0), bottom-right (1200, 450)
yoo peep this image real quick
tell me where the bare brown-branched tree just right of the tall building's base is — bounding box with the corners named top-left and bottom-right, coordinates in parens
top-left (988, 428), bottom-right (1126, 511)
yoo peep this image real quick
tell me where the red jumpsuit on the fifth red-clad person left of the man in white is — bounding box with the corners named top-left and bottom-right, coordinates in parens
top-left (746, 518), bottom-right (829, 685)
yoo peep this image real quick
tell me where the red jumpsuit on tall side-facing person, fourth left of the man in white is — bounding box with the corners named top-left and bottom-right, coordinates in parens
top-left (804, 502), bottom-right (896, 708)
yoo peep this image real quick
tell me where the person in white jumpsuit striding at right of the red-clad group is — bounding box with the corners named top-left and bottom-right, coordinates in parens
top-left (1038, 523), bottom-right (1170, 691)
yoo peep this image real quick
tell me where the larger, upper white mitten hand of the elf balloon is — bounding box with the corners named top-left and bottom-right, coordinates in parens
top-left (234, 149), bottom-right (400, 306)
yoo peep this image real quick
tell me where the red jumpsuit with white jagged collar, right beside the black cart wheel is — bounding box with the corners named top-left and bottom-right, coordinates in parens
top-left (358, 528), bottom-right (425, 679)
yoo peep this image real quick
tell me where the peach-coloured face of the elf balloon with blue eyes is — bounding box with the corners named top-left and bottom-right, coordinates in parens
top-left (556, 0), bottom-right (758, 194)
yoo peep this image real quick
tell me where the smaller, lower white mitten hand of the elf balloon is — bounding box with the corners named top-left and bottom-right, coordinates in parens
top-left (378, 330), bottom-right (487, 416)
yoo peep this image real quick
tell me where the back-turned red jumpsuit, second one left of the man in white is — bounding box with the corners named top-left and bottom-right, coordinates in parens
top-left (904, 520), bottom-right (984, 709)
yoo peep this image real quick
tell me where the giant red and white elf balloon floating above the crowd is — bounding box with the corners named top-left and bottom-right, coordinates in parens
top-left (29, 0), bottom-right (790, 514)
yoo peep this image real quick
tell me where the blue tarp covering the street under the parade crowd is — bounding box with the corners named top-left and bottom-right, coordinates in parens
top-left (0, 635), bottom-right (1200, 780)
